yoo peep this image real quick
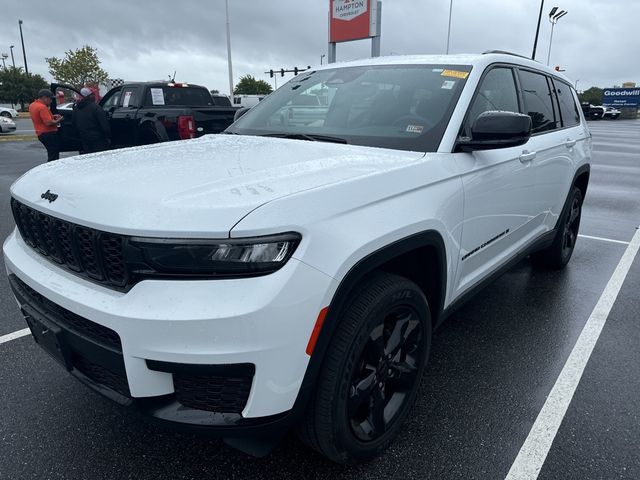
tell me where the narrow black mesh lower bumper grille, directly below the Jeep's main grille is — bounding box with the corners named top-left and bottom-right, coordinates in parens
top-left (11, 275), bottom-right (122, 353)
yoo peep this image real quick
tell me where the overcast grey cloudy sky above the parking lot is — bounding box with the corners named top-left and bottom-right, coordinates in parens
top-left (0, 0), bottom-right (640, 93)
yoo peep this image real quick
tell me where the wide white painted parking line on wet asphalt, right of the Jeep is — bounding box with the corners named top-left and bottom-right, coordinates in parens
top-left (506, 229), bottom-right (640, 480)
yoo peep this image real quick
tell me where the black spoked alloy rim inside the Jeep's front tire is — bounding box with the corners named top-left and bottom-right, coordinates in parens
top-left (347, 306), bottom-right (424, 442)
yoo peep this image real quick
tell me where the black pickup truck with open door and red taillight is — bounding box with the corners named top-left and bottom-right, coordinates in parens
top-left (51, 82), bottom-right (237, 152)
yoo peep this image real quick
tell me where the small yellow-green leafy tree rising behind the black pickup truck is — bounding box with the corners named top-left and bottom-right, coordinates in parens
top-left (45, 45), bottom-right (109, 88)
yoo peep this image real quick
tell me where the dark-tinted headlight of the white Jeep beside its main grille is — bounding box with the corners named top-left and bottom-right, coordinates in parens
top-left (130, 233), bottom-right (301, 277)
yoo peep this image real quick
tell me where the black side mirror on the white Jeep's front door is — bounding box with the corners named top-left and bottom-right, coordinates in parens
top-left (457, 111), bottom-right (532, 152)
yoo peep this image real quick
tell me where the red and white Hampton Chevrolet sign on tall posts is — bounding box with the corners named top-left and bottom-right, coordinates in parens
top-left (329, 0), bottom-right (378, 43)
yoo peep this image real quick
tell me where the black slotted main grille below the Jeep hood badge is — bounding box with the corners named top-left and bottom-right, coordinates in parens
top-left (11, 198), bottom-right (128, 289)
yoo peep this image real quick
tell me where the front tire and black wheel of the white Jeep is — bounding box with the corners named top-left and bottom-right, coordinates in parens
top-left (298, 272), bottom-right (431, 464)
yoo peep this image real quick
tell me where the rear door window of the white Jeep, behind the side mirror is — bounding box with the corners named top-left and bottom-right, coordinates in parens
top-left (519, 70), bottom-right (560, 134)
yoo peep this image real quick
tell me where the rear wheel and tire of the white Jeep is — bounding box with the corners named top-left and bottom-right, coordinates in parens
top-left (531, 187), bottom-right (582, 270)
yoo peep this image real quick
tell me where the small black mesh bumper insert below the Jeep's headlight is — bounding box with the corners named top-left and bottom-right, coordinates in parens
top-left (173, 373), bottom-right (253, 413)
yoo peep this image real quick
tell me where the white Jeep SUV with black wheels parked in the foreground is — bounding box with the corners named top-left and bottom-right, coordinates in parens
top-left (4, 52), bottom-right (591, 463)
